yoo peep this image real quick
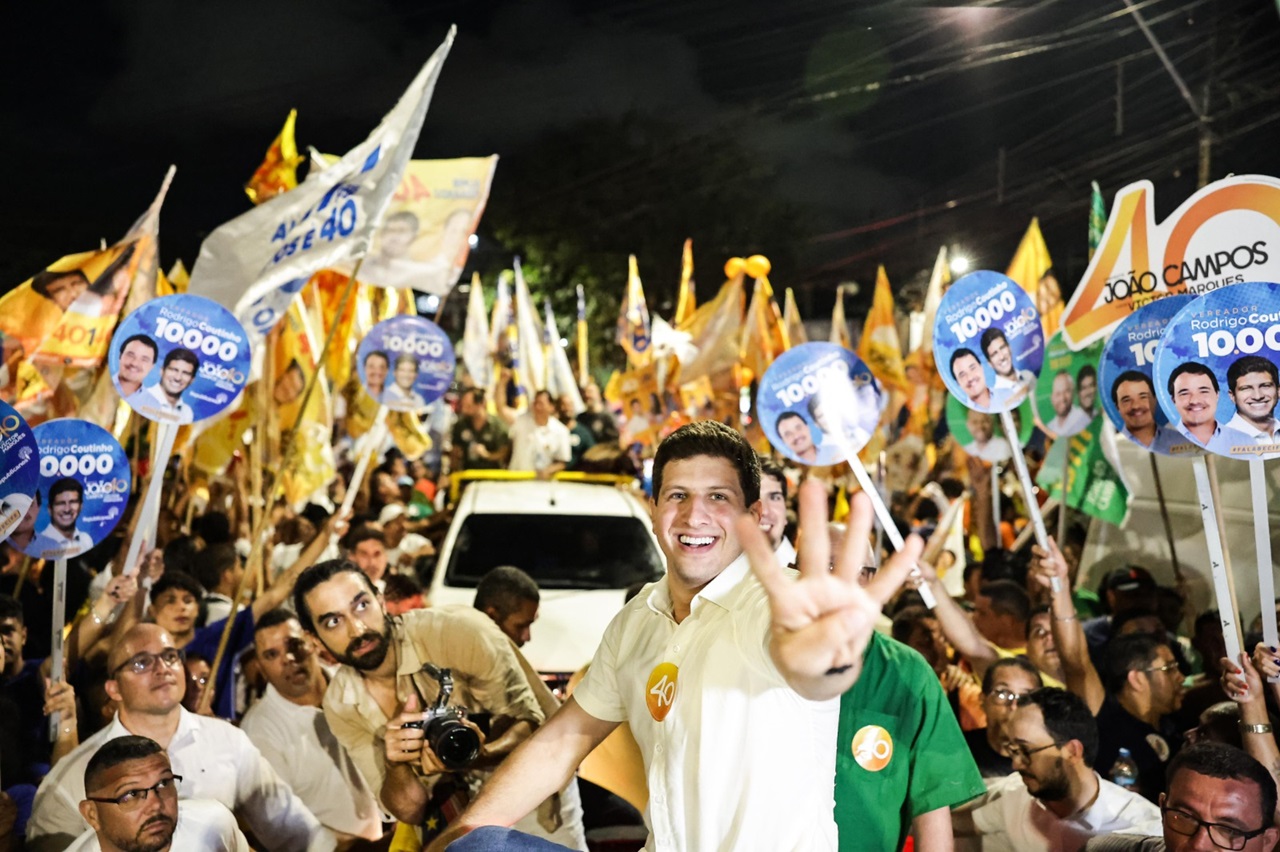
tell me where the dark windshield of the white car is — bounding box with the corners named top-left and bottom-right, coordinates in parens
top-left (444, 514), bottom-right (662, 588)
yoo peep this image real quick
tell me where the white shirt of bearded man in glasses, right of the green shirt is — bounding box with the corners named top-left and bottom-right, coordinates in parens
top-left (973, 773), bottom-right (1160, 852)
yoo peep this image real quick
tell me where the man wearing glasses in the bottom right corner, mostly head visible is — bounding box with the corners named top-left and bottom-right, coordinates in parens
top-left (1084, 742), bottom-right (1280, 852)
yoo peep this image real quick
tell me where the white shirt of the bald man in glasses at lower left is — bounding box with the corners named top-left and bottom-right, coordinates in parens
top-left (27, 707), bottom-right (335, 852)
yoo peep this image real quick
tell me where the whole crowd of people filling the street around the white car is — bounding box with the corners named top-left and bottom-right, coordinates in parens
top-left (0, 370), bottom-right (1280, 852)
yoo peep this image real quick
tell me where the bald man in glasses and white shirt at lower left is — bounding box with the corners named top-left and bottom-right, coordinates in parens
top-left (27, 624), bottom-right (335, 852)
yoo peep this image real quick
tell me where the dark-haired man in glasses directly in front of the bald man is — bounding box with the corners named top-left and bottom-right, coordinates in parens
top-left (68, 737), bottom-right (250, 852)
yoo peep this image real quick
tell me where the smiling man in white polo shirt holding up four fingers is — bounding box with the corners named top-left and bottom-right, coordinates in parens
top-left (430, 421), bottom-right (920, 852)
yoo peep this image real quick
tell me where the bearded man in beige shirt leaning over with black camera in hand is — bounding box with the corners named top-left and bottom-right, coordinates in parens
top-left (293, 559), bottom-right (586, 849)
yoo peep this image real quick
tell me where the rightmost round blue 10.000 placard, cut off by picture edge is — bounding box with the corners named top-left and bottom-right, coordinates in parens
top-left (1156, 281), bottom-right (1280, 459)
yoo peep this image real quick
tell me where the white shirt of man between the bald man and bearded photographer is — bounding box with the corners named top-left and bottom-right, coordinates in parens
top-left (241, 684), bottom-right (383, 840)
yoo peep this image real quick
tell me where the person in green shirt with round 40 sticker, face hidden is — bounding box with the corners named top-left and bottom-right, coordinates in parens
top-left (836, 633), bottom-right (986, 852)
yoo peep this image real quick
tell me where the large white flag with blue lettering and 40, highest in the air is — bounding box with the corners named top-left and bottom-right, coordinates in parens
top-left (188, 28), bottom-right (456, 339)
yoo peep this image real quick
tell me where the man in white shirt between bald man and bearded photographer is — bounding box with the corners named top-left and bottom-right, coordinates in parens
top-left (241, 609), bottom-right (383, 840)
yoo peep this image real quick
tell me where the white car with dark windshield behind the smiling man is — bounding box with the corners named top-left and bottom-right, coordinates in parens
top-left (430, 480), bottom-right (664, 687)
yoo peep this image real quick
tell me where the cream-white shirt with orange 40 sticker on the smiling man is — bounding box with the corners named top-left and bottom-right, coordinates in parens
top-left (573, 556), bottom-right (840, 852)
